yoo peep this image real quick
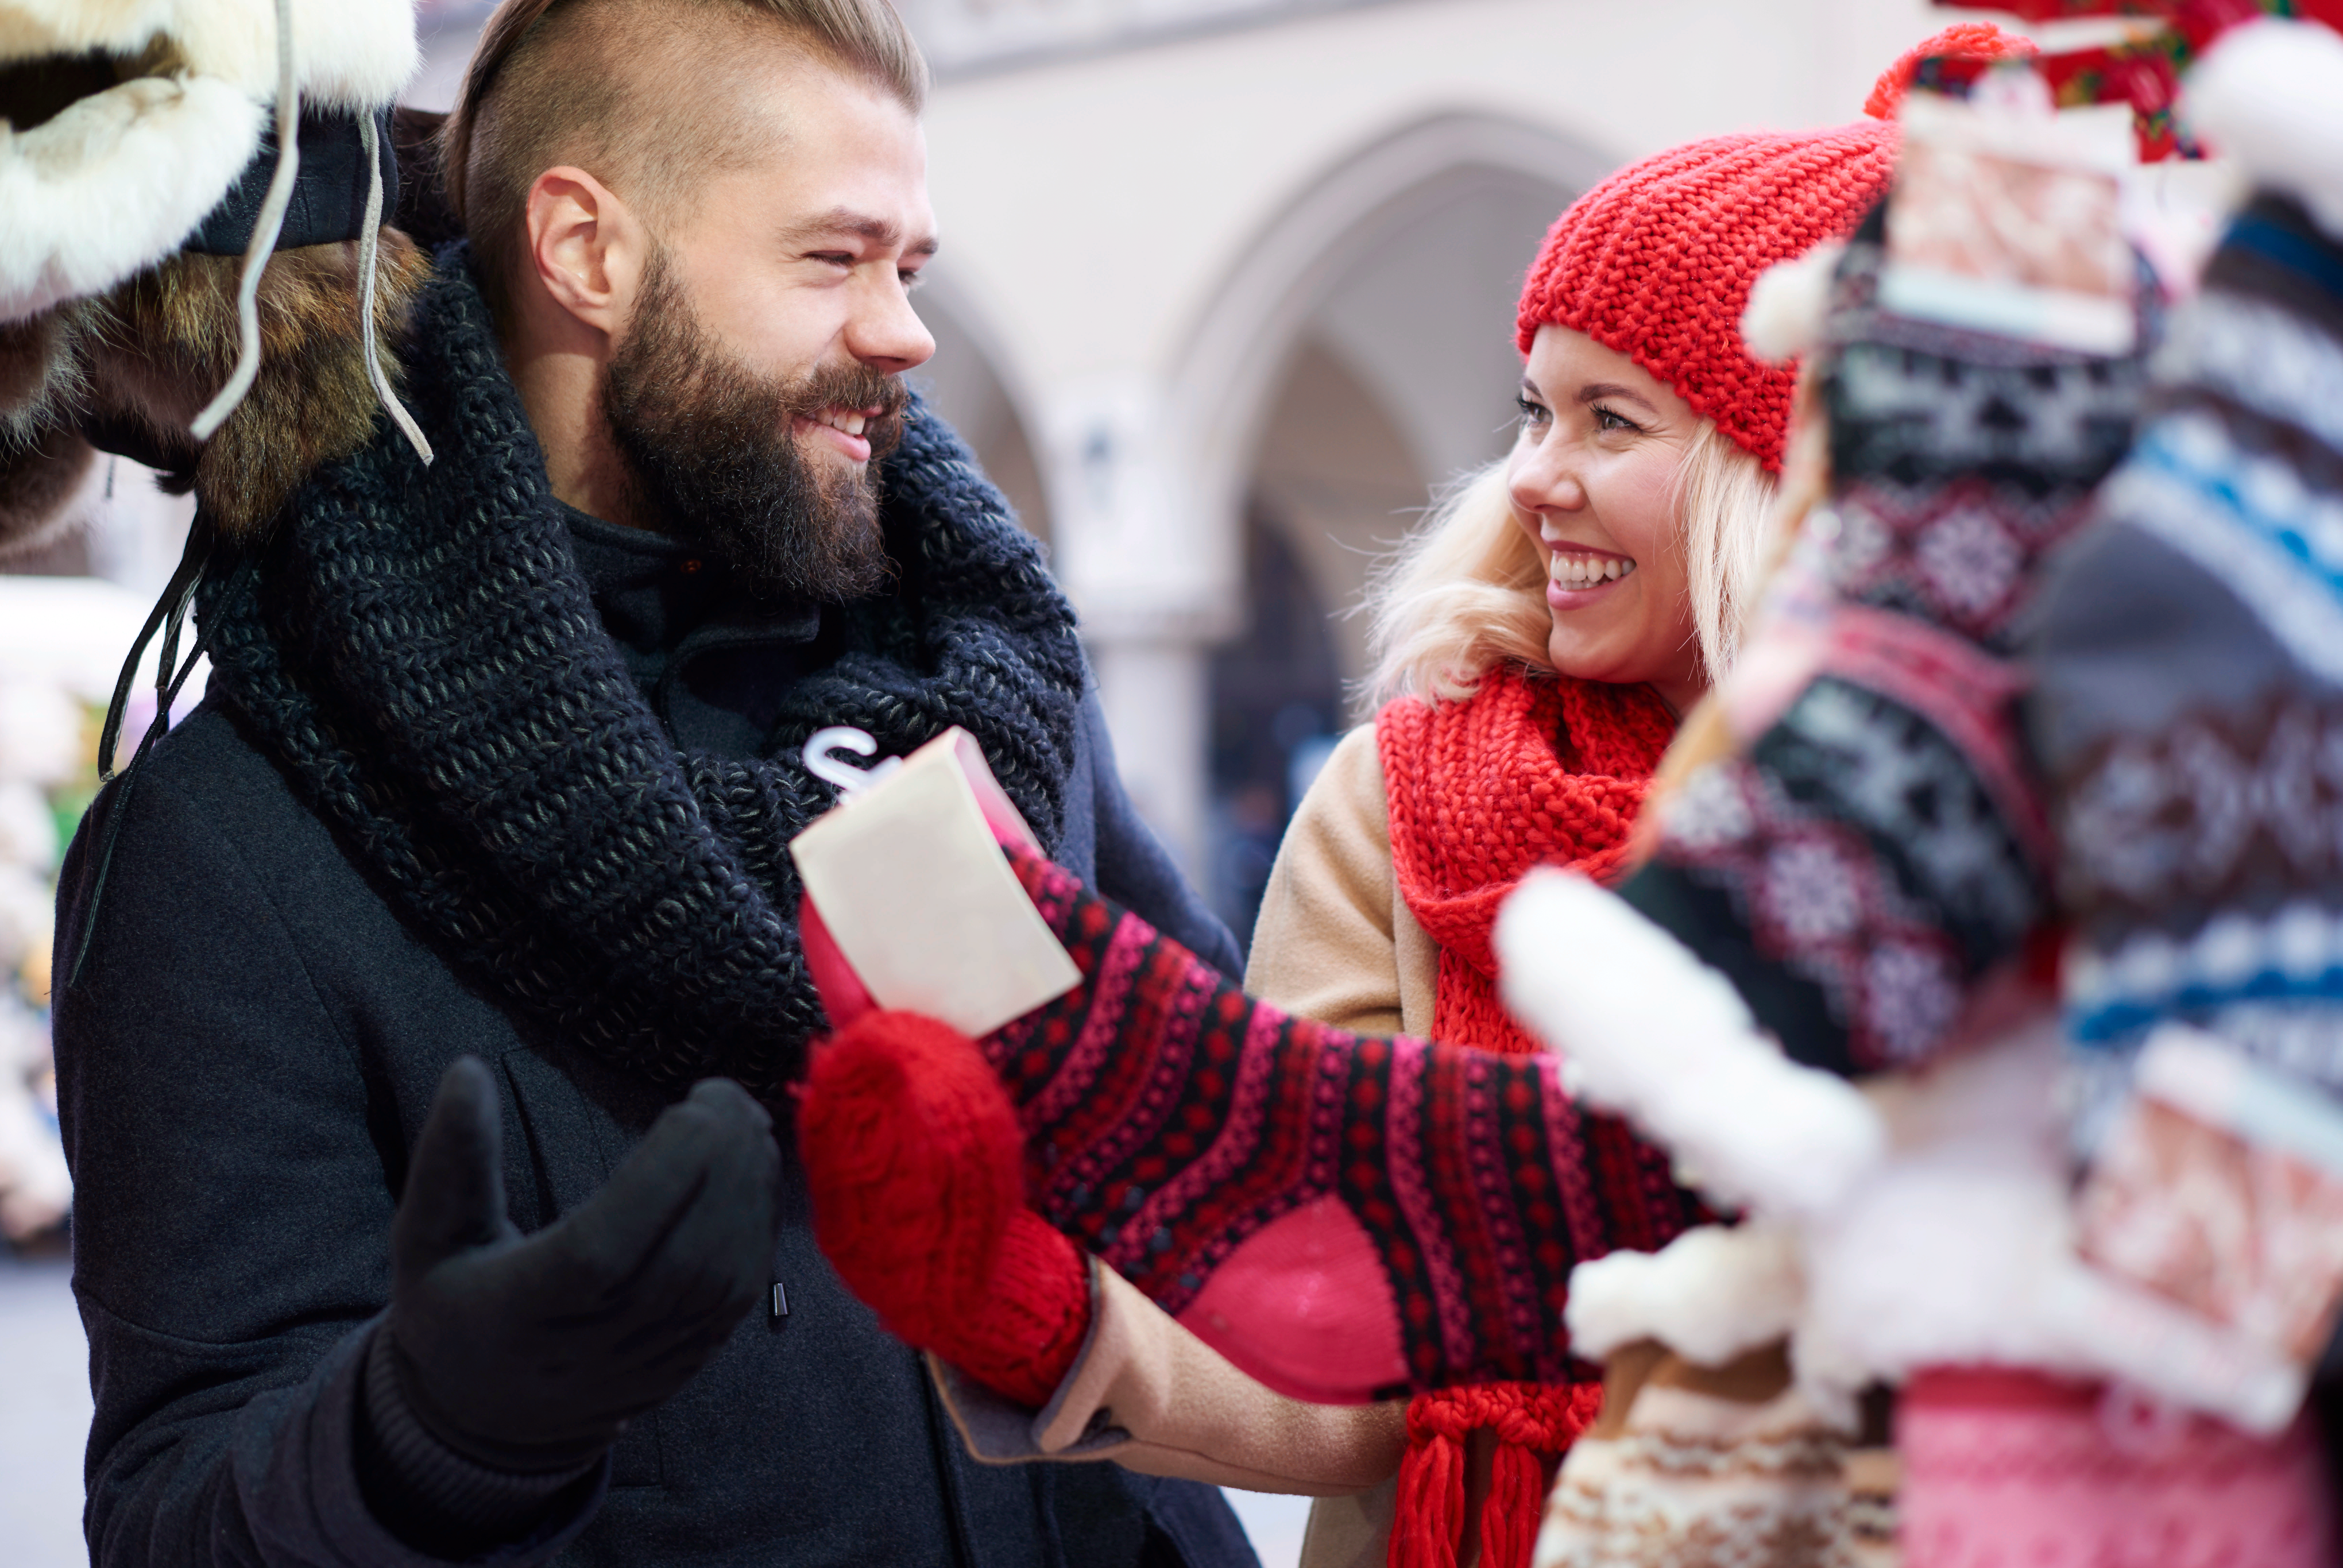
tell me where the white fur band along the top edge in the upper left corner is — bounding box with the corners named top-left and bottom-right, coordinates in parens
top-left (0, 0), bottom-right (417, 108)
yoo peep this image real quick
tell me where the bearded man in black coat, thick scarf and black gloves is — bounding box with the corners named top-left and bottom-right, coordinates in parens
top-left (56, 0), bottom-right (1251, 1568)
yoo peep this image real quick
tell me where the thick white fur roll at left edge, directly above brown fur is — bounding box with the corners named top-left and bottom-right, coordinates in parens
top-left (0, 77), bottom-right (260, 321)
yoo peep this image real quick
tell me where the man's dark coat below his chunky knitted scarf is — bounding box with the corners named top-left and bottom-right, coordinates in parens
top-left (56, 539), bottom-right (1253, 1568)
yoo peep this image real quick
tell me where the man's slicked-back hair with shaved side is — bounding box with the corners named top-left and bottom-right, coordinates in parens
top-left (440, 0), bottom-right (928, 321)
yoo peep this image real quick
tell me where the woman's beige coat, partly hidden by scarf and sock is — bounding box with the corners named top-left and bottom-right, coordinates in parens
top-left (935, 727), bottom-right (1439, 1568)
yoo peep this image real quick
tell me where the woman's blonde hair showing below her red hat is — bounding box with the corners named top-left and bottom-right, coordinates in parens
top-left (1361, 419), bottom-right (1774, 708)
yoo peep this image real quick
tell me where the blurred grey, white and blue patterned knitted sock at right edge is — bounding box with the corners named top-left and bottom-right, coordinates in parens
top-left (2031, 195), bottom-right (2343, 1144)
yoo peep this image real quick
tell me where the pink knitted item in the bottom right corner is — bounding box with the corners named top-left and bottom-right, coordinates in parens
top-left (1896, 1369), bottom-right (2334, 1568)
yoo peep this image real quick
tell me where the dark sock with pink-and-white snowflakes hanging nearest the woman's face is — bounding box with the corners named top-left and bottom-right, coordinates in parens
top-left (1621, 213), bottom-right (2156, 1073)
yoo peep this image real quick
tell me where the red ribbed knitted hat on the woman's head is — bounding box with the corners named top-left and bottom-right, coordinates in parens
top-left (1516, 24), bottom-right (2034, 471)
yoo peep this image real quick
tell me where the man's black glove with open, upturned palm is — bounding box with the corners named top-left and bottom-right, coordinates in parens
top-left (377, 1057), bottom-right (780, 1474)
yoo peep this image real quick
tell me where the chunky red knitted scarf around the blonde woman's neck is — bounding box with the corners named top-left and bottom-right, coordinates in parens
top-left (1375, 663), bottom-right (1675, 1568)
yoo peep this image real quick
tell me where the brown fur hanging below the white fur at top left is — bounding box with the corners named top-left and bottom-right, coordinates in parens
top-left (15, 230), bottom-right (431, 539)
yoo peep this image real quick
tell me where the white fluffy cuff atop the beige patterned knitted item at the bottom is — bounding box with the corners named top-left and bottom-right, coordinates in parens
top-left (1563, 1223), bottom-right (1806, 1366)
